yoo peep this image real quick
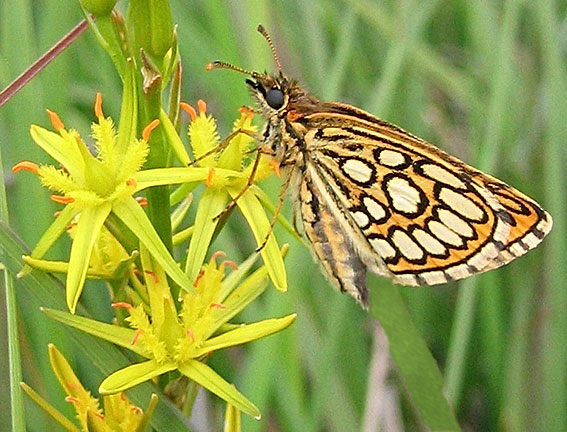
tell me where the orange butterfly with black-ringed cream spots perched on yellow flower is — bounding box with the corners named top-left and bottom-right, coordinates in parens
top-left (208, 25), bottom-right (552, 308)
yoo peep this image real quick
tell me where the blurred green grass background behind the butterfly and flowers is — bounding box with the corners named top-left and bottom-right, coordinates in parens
top-left (0, 0), bottom-right (567, 431)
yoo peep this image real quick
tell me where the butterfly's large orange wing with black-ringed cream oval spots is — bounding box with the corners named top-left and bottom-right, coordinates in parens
top-left (294, 104), bottom-right (552, 285)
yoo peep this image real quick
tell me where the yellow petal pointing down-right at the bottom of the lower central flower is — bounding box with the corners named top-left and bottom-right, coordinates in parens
top-left (179, 360), bottom-right (260, 418)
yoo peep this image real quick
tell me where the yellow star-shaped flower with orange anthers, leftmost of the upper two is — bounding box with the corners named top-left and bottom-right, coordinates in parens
top-left (14, 93), bottom-right (193, 313)
